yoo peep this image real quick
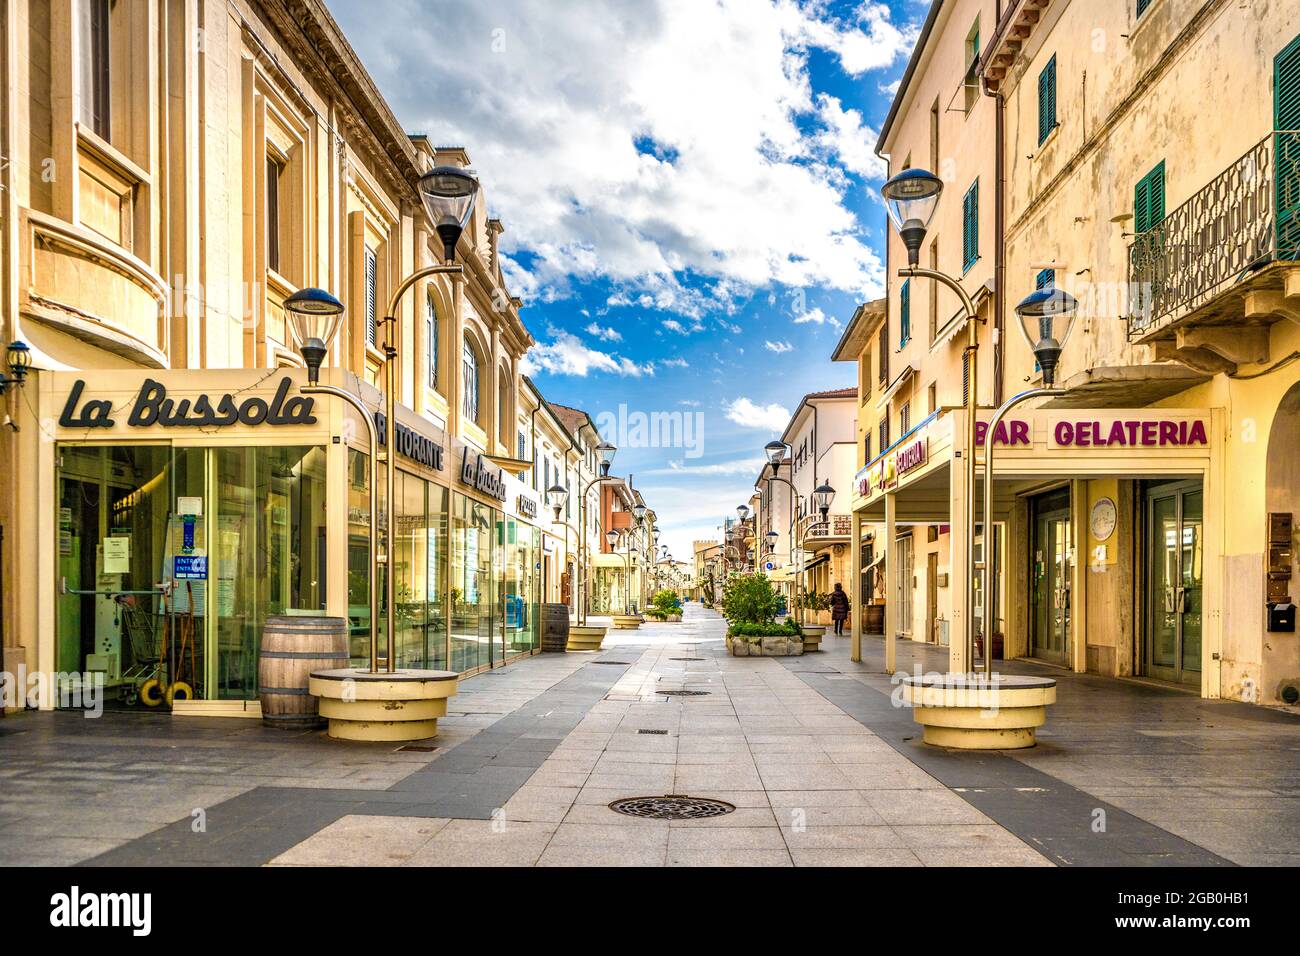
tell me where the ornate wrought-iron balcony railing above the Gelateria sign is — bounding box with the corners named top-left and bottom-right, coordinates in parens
top-left (1128, 131), bottom-right (1300, 338)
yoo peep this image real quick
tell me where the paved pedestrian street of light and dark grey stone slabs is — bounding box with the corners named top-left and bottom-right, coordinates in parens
top-left (0, 604), bottom-right (1300, 866)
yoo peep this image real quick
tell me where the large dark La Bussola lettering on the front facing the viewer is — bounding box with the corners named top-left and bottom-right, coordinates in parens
top-left (59, 377), bottom-right (316, 428)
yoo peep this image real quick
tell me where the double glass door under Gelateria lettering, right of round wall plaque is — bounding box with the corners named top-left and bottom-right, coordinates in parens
top-left (1144, 481), bottom-right (1205, 684)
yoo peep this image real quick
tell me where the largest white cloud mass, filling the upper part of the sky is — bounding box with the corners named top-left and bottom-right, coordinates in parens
top-left (329, 0), bottom-right (911, 317)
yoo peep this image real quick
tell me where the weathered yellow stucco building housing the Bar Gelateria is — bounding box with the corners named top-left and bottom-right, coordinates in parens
top-left (841, 0), bottom-right (1300, 705)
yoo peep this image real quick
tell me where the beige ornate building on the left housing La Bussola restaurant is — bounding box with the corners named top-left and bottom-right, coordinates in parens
top-left (0, 0), bottom-right (634, 715)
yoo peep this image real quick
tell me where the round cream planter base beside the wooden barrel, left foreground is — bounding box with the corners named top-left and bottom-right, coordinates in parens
top-left (308, 667), bottom-right (459, 740)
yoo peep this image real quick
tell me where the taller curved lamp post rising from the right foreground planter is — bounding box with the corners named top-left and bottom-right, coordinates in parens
top-left (880, 169), bottom-right (979, 669)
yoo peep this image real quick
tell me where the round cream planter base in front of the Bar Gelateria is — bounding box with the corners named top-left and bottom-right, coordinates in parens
top-left (902, 674), bottom-right (1056, 750)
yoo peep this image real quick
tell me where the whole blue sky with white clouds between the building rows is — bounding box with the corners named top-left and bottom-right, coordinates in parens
top-left (328, 0), bottom-right (928, 559)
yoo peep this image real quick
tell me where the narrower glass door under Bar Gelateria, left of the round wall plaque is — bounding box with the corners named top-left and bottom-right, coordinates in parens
top-left (1030, 490), bottom-right (1074, 663)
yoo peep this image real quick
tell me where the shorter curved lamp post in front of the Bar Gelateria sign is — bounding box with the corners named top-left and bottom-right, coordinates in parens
top-left (971, 286), bottom-right (1079, 679)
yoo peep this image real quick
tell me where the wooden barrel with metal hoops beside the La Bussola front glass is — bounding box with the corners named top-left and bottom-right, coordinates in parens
top-left (257, 615), bottom-right (348, 730)
